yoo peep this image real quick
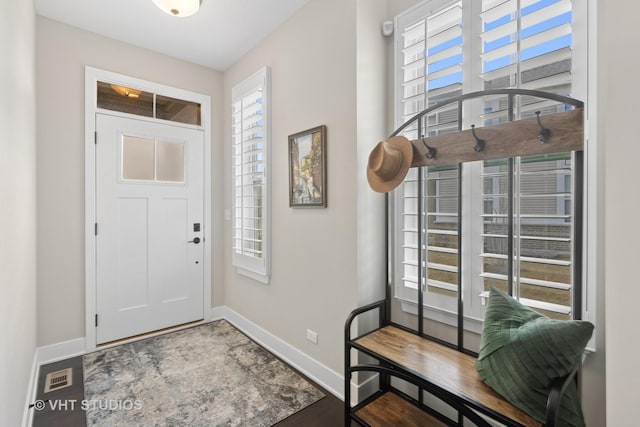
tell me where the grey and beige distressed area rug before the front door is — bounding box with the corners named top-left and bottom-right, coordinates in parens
top-left (83, 320), bottom-right (324, 427)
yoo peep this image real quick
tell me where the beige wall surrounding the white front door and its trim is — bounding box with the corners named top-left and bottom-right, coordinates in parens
top-left (36, 17), bottom-right (223, 346)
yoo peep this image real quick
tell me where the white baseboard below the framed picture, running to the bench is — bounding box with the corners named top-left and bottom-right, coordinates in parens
top-left (216, 307), bottom-right (344, 400)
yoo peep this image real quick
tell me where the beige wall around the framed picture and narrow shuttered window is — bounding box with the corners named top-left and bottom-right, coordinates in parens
top-left (224, 0), bottom-right (357, 372)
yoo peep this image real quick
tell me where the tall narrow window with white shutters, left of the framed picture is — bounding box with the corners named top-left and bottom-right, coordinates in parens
top-left (231, 68), bottom-right (270, 283)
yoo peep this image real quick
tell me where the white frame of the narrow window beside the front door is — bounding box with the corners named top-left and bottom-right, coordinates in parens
top-left (229, 66), bottom-right (272, 284)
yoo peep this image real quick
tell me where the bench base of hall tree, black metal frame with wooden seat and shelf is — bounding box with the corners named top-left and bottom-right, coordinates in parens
top-left (345, 300), bottom-right (577, 427)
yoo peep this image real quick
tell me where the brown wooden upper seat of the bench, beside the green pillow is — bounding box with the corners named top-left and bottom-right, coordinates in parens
top-left (355, 326), bottom-right (541, 427)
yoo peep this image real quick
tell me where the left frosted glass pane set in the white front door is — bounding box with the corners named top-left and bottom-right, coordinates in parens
top-left (122, 135), bottom-right (155, 181)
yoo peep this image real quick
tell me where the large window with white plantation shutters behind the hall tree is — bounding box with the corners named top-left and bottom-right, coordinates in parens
top-left (394, 0), bottom-right (586, 331)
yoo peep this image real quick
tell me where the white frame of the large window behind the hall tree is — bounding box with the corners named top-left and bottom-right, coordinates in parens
top-left (389, 0), bottom-right (595, 340)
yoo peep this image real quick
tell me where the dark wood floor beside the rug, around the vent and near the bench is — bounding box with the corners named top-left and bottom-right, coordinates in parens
top-left (31, 356), bottom-right (344, 427)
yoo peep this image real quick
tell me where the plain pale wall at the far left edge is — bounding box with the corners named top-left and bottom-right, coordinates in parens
top-left (0, 0), bottom-right (36, 426)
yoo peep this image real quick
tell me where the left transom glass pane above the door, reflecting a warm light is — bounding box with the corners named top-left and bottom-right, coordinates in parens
top-left (97, 82), bottom-right (153, 117)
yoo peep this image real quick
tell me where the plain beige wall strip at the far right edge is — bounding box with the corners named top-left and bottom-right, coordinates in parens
top-left (598, 0), bottom-right (640, 427)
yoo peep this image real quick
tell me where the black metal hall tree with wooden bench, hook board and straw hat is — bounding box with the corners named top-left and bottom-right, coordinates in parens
top-left (344, 89), bottom-right (592, 427)
